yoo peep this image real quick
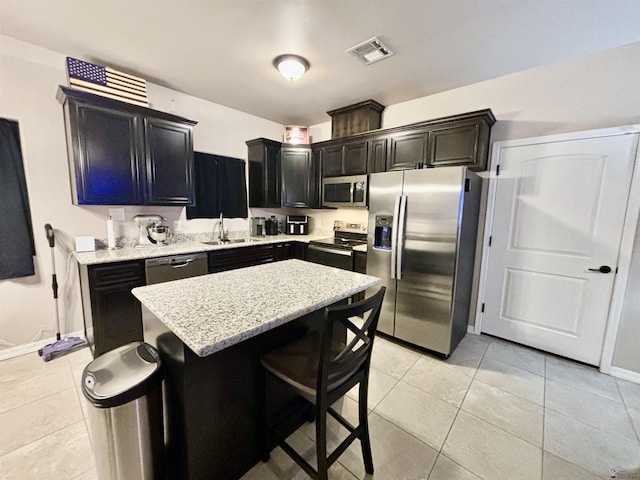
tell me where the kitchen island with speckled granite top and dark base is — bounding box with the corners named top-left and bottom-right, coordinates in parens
top-left (132, 260), bottom-right (380, 480)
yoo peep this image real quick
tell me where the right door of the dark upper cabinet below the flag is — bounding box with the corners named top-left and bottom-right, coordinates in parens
top-left (145, 118), bottom-right (195, 205)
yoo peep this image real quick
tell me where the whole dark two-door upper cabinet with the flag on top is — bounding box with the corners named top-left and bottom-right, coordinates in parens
top-left (58, 87), bottom-right (196, 206)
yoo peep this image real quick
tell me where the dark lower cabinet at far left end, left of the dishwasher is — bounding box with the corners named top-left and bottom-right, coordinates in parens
top-left (80, 261), bottom-right (145, 357)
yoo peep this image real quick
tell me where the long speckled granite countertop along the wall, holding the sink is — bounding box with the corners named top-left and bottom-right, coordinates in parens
top-left (74, 233), bottom-right (332, 265)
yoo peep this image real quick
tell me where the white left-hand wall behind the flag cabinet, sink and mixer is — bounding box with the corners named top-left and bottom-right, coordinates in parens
top-left (0, 35), bottom-right (283, 358)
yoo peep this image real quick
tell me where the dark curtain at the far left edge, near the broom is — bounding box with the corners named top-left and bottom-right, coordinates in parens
top-left (0, 118), bottom-right (36, 280)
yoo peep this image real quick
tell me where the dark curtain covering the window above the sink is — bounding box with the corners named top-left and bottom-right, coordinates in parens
top-left (187, 152), bottom-right (248, 219)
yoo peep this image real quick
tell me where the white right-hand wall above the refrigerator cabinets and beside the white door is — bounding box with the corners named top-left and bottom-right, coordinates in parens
top-left (312, 43), bottom-right (640, 373)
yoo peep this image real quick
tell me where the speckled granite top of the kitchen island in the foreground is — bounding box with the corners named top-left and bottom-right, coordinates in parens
top-left (132, 260), bottom-right (381, 357)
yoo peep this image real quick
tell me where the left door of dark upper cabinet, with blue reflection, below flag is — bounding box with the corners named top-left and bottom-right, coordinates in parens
top-left (72, 102), bottom-right (143, 205)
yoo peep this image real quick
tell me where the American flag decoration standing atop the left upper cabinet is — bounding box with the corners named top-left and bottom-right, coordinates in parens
top-left (67, 57), bottom-right (149, 107)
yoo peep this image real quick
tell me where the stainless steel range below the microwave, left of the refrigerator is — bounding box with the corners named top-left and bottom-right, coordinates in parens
top-left (307, 220), bottom-right (367, 270)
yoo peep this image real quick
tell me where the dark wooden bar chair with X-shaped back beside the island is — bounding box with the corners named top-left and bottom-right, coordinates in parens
top-left (261, 287), bottom-right (385, 480)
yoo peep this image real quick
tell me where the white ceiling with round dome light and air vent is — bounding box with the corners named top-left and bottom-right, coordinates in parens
top-left (0, 0), bottom-right (640, 125)
